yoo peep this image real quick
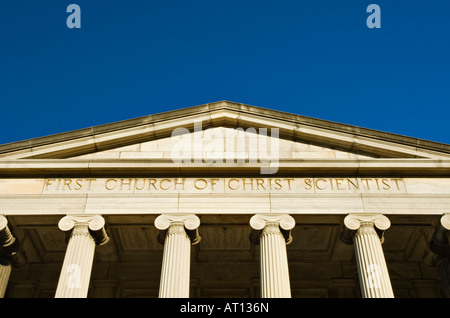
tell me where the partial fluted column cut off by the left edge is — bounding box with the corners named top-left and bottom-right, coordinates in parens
top-left (0, 215), bottom-right (28, 298)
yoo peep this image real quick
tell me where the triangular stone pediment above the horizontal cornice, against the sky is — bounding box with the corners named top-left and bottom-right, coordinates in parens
top-left (0, 101), bottom-right (450, 160)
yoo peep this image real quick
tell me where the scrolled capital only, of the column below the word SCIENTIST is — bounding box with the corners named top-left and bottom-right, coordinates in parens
top-left (341, 213), bottom-right (391, 244)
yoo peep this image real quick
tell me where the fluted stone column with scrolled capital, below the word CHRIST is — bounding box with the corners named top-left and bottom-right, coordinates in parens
top-left (250, 214), bottom-right (295, 298)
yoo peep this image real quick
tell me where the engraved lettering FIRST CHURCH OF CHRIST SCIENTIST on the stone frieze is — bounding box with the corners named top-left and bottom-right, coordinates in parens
top-left (43, 177), bottom-right (406, 194)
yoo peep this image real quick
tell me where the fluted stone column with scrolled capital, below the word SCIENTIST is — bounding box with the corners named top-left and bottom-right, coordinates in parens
top-left (341, 214), bottom-right (394, 298)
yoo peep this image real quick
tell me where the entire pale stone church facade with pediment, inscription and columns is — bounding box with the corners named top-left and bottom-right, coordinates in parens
top-left (0, 101), bottom-right (450, 298)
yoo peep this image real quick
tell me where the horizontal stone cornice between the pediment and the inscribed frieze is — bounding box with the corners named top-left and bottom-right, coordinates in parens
top-left (0, 159), bottom-right (450, 178)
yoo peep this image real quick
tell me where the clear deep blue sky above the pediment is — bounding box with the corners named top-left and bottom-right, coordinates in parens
top-left (0, 0), bottom-right (450, 144)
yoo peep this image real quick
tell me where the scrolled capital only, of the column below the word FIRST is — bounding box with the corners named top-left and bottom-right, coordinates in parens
top-left (58, 215), bottom-right (109, 245)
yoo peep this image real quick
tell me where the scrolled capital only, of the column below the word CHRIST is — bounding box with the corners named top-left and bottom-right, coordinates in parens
top-left (249, 214), bottom-right (295, 244)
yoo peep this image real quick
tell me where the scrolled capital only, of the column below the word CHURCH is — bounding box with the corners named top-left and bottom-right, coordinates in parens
top-left (155, 214), bottom-right (201, 245)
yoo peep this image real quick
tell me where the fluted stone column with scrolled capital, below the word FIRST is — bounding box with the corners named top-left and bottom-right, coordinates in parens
top-left (55, 215), bottom-right (109, 298)
